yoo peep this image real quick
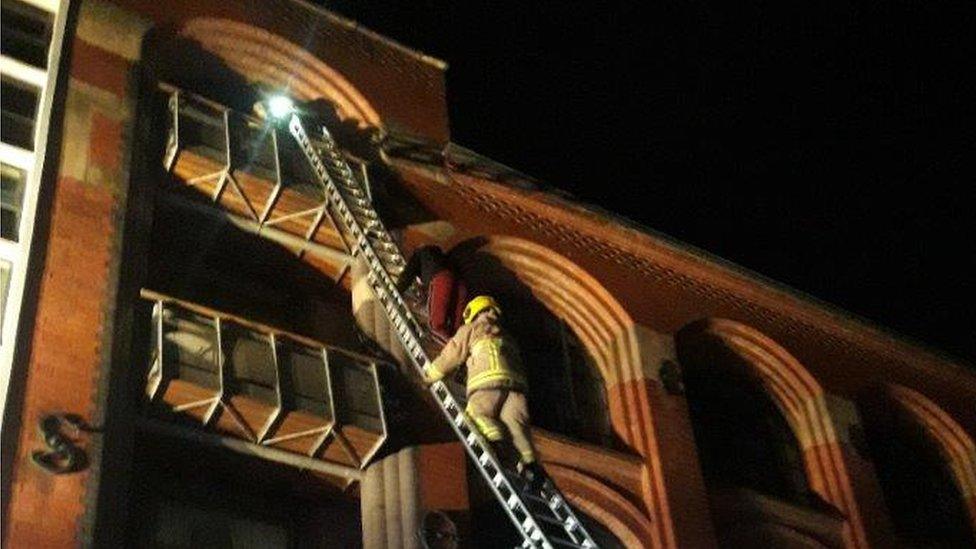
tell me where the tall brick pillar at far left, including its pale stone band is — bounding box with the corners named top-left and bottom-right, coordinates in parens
top-left (4, 26), bottom-right (131, 547)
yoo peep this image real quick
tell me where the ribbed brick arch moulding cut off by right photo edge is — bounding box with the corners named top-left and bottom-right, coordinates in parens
top-left (884, 385), bottom-right (976, 530)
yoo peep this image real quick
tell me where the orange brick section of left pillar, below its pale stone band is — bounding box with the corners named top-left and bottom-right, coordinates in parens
top-left (4, 179), bottom-right (115, 547)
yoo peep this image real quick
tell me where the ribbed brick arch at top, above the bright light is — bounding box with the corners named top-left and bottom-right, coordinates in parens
top-left (178, 17), bottom-right (380, 128)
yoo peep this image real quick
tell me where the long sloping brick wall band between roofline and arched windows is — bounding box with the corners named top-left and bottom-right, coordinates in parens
top-left (397, 162), bottom-right (976, 424)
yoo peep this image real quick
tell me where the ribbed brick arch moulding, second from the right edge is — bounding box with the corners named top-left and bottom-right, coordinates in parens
top-left (676, 318), bottom-right (868, 547)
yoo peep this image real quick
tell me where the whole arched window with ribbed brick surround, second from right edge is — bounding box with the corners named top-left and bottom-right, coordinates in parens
top-left (675, 319), bottom-right (865, 547)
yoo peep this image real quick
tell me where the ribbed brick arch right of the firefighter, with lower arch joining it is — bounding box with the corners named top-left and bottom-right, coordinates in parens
top-left (452, 236), bottom-right (675, 546)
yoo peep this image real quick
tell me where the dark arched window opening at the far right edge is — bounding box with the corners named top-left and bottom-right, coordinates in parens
top-left (862, 390), bottom-right (976, 547)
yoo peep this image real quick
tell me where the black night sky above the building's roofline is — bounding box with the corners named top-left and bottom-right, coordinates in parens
top-left (326, 0), bottom-right (976, 363)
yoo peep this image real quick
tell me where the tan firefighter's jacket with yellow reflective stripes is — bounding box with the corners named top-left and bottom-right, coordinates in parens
top-left (426, 311), bottom-right (528, 395)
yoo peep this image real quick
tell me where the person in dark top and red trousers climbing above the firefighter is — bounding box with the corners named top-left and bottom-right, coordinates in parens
top-left (397, 246), bottom-right (468, 341)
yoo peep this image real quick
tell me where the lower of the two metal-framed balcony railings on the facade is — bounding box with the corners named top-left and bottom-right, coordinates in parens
top-left (143, 290), bottom-right (386, 468)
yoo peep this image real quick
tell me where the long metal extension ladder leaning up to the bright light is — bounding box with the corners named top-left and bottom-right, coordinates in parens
top-left (288, 113), bottom-right (597, 549)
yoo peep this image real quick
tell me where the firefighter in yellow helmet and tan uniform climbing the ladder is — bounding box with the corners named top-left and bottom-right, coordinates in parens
top-left (424, 295), bottom-right (544, 488)
